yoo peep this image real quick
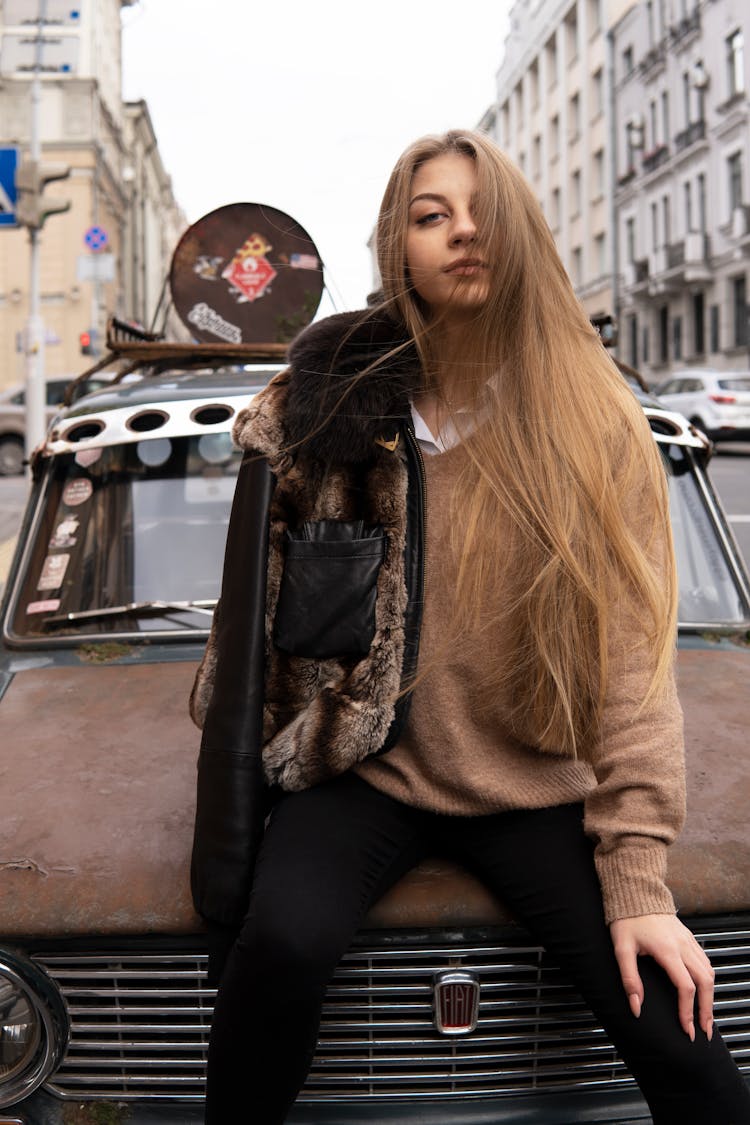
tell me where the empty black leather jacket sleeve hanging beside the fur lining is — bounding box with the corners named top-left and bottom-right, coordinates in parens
top-left (191, 455), bottom-right (273, 927)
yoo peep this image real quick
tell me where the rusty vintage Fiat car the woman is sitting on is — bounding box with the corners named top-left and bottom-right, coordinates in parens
top-left (0, 330), bottom-right (750, 1125)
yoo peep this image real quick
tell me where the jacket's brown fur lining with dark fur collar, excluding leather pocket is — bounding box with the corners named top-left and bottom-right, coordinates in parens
top-left (191, 311), bottom-right (419, 790)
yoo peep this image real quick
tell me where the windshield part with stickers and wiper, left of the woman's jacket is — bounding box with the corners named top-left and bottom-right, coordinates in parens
top-left (12, 433), bottom-right (241, 638)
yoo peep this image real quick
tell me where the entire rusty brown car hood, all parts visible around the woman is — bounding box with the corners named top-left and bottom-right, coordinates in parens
top-left (0, 646), bottom-right (750, 937)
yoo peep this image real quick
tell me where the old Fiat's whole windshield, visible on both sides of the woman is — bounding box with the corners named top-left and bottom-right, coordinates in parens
top-left (2, 433), bottom-right (748, 642)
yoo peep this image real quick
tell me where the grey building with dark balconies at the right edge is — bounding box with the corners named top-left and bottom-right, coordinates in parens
top-left (611, 0), bottom-right (750, 384)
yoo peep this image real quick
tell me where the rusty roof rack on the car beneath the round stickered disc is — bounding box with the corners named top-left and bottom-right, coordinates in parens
top-left (63, 316), bottom-right (289, 406)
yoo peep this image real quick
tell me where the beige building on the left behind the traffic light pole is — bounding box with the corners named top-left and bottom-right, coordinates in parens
top-left (0, 0), bottom-right (187, 386)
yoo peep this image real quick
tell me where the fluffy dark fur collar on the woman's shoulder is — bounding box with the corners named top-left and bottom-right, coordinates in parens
top-left (234, 309), bottom-right (419, 465)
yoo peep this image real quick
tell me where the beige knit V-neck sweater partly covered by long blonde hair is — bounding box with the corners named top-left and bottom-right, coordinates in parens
top-left (358, 446), bottom-right (685, 921)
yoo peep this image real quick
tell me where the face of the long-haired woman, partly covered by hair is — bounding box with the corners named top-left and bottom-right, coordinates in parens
top-left (406, 153), bottom-right (489, 320)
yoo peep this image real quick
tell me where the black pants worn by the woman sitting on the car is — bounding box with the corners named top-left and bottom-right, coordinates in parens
top-left (206, 775), bottom-right (750, 1125)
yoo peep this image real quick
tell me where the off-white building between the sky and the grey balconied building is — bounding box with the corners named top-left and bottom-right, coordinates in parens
top-left (480, 0), bottom-right (622, 326)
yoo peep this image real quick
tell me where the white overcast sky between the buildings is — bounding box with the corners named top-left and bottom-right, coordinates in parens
top-left (123, 0), bottom-right (508, 312)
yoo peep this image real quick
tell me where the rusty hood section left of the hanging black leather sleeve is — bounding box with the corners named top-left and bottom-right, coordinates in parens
top-left (0, 663), bottom-right (200, 936)
